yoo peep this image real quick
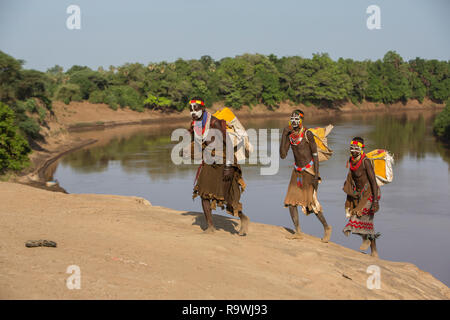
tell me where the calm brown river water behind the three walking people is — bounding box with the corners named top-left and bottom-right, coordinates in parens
top-left (54, 111), bottom-right (450, 286)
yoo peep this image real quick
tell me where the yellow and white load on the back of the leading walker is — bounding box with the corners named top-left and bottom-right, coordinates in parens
top-left (213, 107), bottom-right (253, 162)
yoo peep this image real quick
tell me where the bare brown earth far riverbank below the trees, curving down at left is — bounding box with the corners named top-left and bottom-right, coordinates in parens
top-left (9, 99), bottom-right (444, 192)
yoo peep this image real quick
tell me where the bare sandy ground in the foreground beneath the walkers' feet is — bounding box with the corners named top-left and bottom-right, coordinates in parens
top-left (0, 182), bottom-right (450, 299)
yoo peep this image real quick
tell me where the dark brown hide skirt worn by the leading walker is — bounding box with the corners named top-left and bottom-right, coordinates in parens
top-left (192, 163), bottom-right (245, 217)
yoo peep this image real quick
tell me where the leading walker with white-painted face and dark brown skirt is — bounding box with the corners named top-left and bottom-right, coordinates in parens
top-left (189, 97), bottom-right (250, 236)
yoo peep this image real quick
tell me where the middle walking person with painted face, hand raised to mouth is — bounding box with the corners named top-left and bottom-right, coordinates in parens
top-left (280, 110), bottom-right (332, 242)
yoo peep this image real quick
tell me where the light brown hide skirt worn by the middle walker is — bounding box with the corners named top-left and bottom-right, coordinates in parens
top-left (284, 169), bottom-right (322, 215)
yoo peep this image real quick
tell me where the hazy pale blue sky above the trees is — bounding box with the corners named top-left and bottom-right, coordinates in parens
top-left (0, 0), bottom-right (450, 70)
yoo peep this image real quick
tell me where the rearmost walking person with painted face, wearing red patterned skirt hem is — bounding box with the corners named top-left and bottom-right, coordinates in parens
top-left (343, 137), bottom-right (380, 257)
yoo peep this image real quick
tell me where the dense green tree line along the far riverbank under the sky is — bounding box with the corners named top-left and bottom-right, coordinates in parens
top-left (0, 51), bottom-right (450, 172)
